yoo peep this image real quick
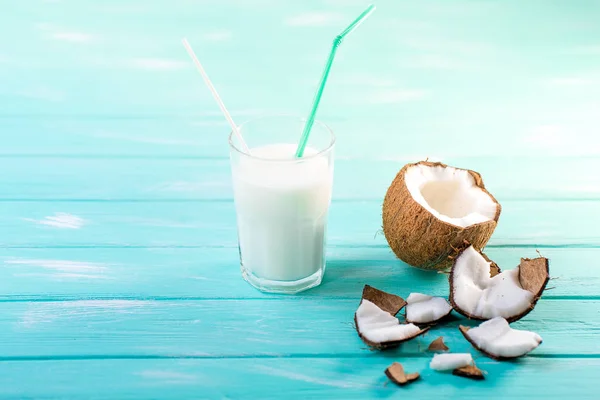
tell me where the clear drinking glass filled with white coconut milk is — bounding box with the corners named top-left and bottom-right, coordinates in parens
top-left (229, 116), bottom-right (335, 293)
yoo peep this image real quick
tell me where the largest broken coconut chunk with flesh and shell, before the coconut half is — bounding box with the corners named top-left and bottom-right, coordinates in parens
top-left (450, 246), bottom-right (549, 322)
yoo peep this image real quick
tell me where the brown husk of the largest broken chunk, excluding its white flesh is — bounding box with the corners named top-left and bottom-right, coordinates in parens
top-left (448, 247), bottom-right (550, 324)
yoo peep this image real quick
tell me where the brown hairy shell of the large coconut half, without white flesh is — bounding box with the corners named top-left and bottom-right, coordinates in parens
top-left (383, 161), bottom-right (501, 271)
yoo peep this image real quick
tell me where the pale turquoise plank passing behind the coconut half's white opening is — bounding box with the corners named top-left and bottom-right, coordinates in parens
top-left (0, 156), bottom-right (600, 201)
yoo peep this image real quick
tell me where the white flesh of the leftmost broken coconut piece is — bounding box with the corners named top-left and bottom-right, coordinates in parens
top-left (355, 300), bottom-right (421, 343)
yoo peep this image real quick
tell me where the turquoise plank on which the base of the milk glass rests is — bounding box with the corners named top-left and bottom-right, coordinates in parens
top-left (0, 247), bottom-right (600, 301)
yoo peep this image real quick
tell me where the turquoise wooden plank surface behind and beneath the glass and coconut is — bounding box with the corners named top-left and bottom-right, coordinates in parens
top-left (0, 0), bottom-right (600, 399)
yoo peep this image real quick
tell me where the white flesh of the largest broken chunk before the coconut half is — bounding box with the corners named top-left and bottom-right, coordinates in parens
top-left (450, 246), bottom-right (534, 319)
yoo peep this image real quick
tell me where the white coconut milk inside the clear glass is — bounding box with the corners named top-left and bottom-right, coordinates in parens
top-left (232, 144), bottom-right (333, 281)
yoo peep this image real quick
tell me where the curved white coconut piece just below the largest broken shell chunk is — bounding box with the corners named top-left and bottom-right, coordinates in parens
top-left (458, 317), bottom-right (542, 360)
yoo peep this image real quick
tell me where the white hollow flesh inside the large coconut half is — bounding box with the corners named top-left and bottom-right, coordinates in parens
top-left (404, 164), bottom-right (498, 228)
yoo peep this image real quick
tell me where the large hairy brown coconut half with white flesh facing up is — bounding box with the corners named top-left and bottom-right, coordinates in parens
top-left (383, 161), bottom-right (501, 270)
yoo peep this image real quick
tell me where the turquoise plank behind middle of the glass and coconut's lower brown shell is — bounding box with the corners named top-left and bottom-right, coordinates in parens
top-left (0, 201), bottom-right (600, 247)
